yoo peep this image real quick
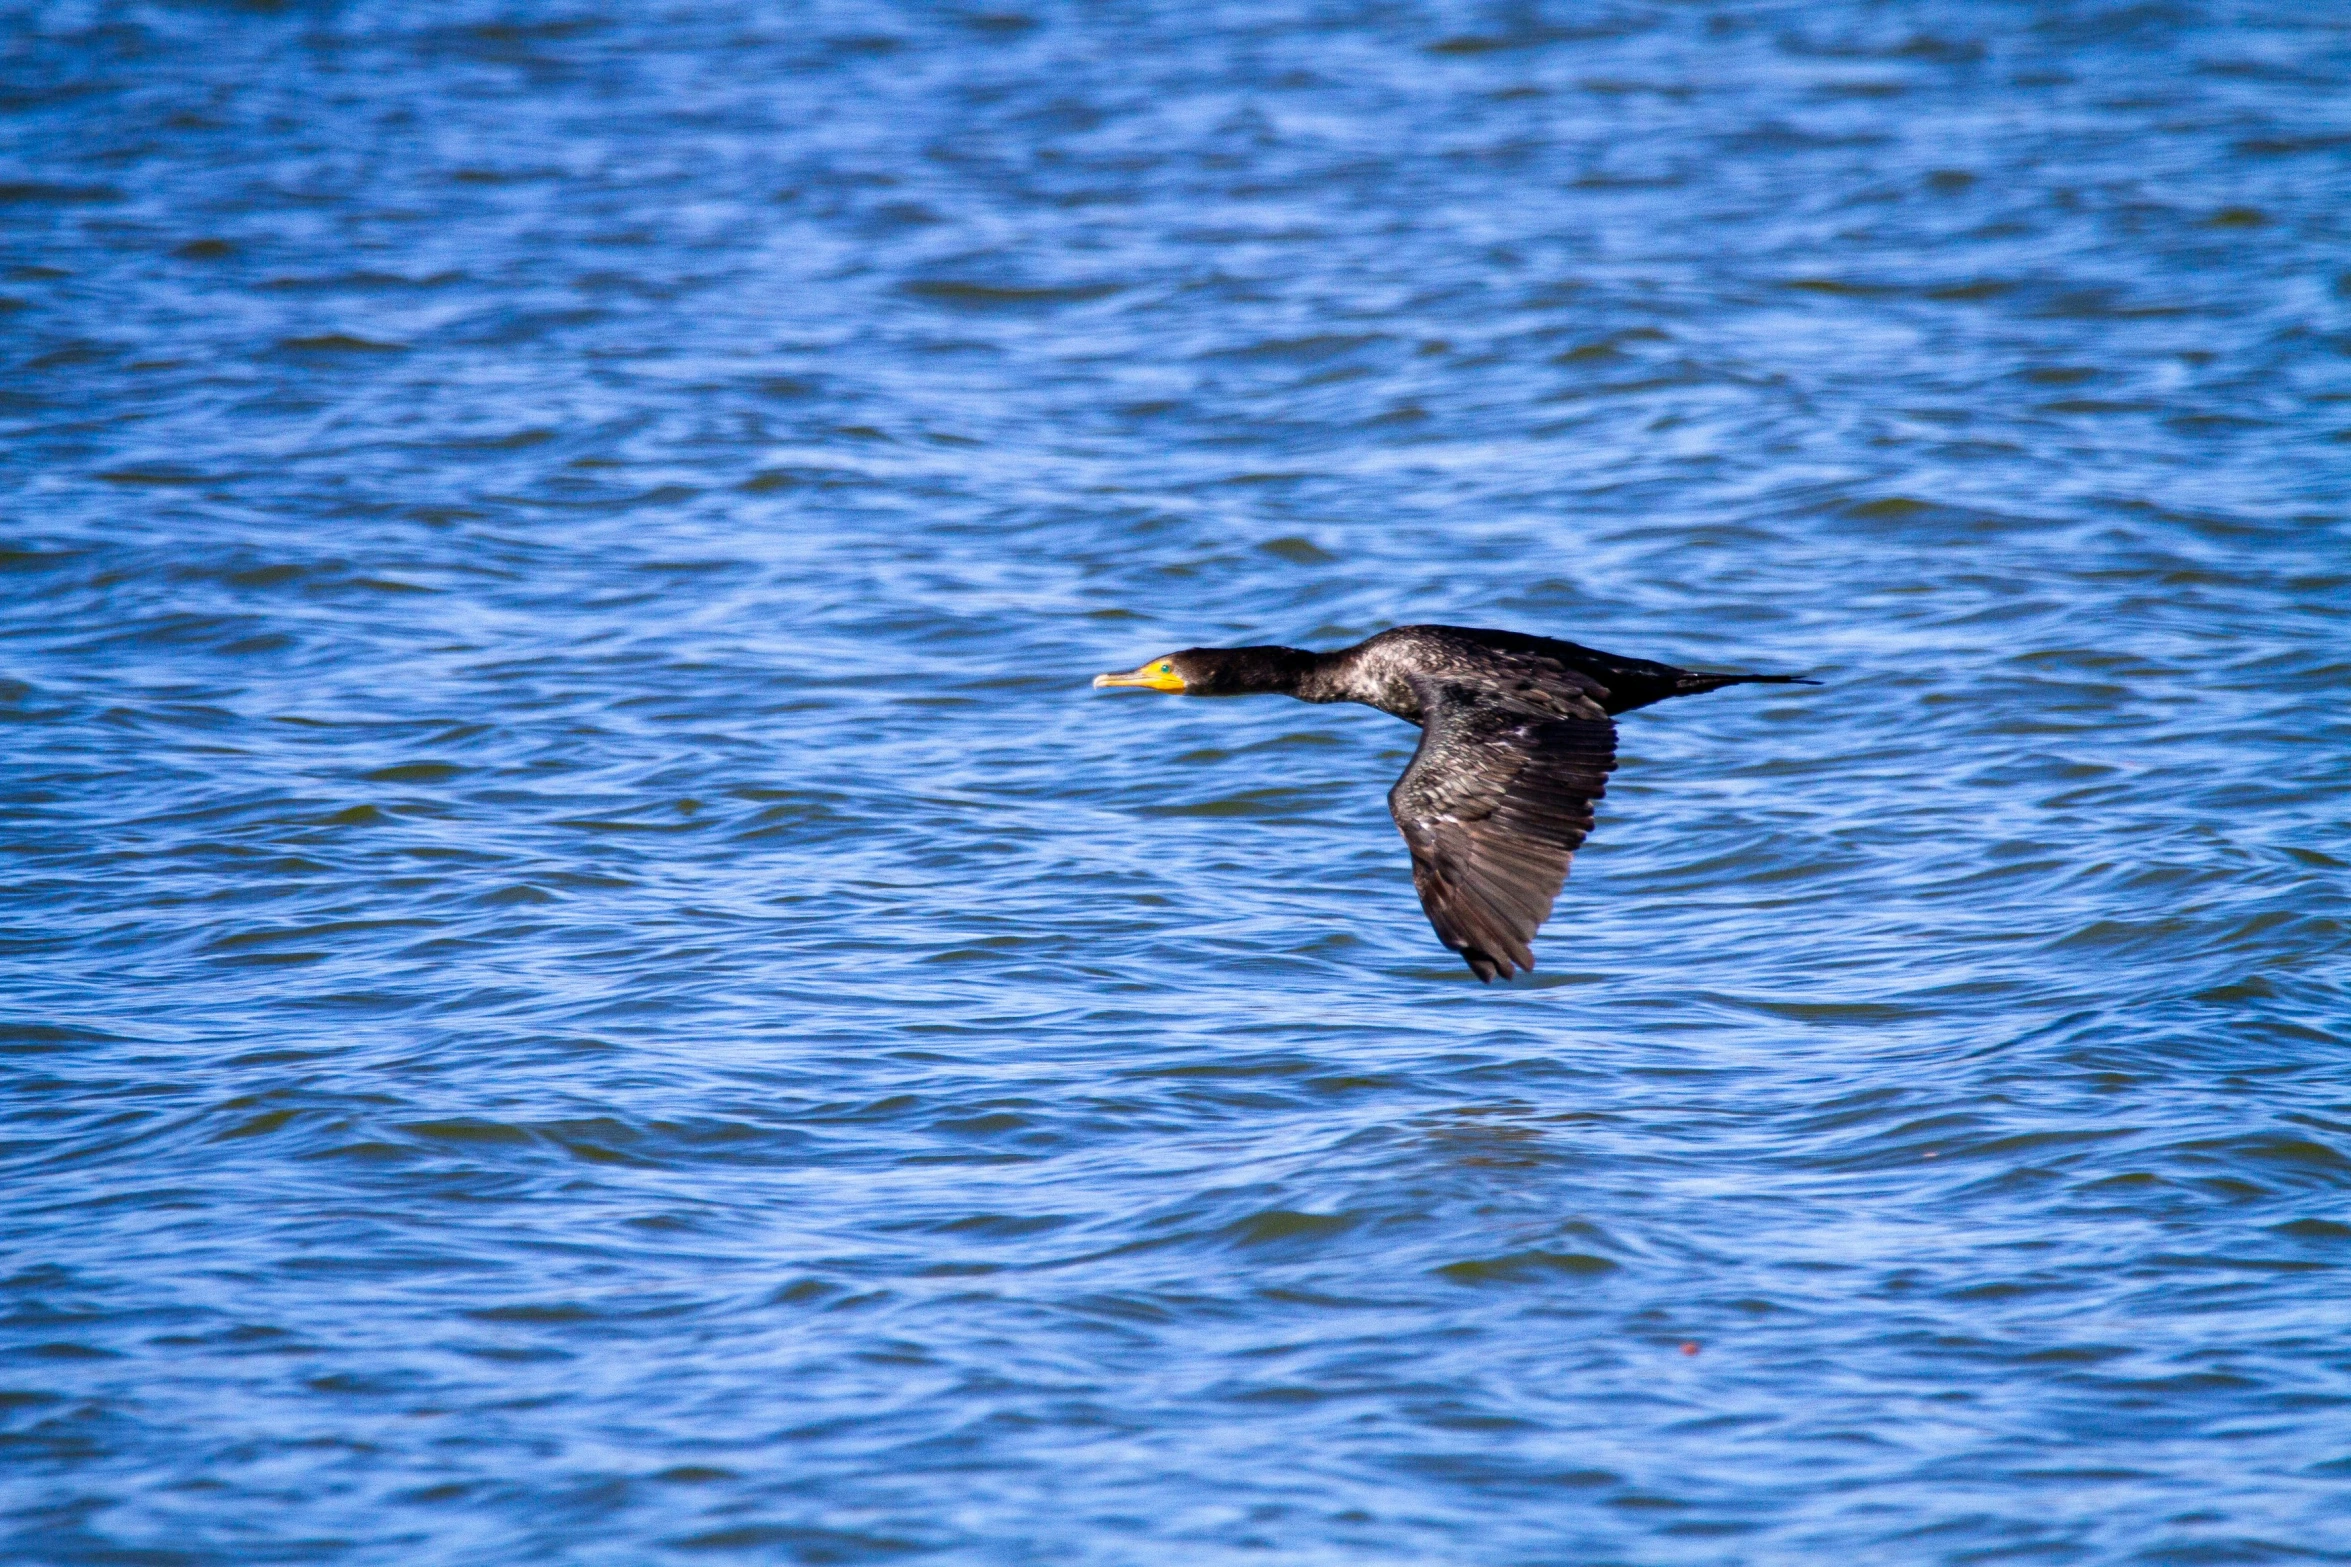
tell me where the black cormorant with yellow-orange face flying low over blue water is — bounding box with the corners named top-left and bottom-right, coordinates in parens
top-left (1093, 625), bottom-right (1817, 980)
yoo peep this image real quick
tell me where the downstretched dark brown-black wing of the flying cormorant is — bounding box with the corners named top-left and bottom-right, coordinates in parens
top-left (1387, 679), bottom-right (1615, 980)
